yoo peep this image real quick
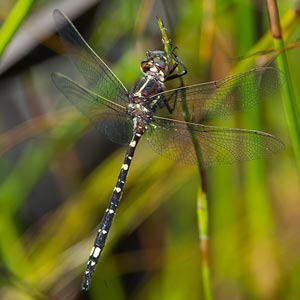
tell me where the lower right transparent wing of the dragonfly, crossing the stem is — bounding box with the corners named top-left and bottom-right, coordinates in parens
top-left (148, 117), bottom-right (284, 167)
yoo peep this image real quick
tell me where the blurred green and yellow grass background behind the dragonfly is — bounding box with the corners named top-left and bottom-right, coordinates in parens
top-left (0, 0), bottom-right (300, 300)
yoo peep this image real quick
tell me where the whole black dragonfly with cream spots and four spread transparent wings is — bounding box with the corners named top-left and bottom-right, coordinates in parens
top-left (52, 10), bottom-right (284, 291)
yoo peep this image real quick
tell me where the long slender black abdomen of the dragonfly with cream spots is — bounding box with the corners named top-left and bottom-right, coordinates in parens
top-left (82, 133), bottom-right (141, 291)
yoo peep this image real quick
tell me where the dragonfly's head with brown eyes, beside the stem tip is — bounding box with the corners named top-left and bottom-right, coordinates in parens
top-left (141, 50), bottom-right (169, 81)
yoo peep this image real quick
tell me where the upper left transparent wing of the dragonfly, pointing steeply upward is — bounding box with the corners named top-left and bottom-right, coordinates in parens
top-left (53, 9), bottom-right (128, 105)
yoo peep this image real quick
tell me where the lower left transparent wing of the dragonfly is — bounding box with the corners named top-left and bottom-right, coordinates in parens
top-left (52, 73), bottom-right (133, 144)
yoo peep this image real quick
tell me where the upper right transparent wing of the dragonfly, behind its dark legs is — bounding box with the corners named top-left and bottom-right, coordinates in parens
top-left (153, 67), bottom-right (285, 123)
